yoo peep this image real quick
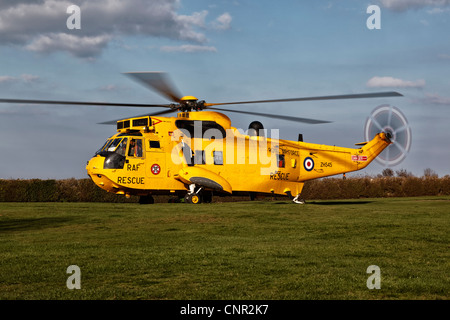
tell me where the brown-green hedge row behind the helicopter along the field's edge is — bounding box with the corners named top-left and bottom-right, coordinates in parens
top-left (0, 176), bottom-right (450, 202)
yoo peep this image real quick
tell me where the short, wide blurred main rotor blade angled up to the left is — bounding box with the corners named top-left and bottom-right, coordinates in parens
top-left (124, 72), bottom-right (182, 103)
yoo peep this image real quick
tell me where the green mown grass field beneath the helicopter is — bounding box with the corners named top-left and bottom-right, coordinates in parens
top-left (0, 197), bottom-right (450, 300)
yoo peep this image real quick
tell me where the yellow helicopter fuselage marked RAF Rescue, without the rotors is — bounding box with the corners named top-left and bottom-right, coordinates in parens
top-left (86, 112), bottom-right (391, 199)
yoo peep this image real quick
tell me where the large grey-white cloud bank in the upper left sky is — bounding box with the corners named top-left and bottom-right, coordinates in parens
top-left (0, 0), bottom-right (231, 58)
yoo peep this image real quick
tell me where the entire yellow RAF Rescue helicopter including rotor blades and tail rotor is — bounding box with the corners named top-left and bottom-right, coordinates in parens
top-left (0, 72), bottom-right (410, 204)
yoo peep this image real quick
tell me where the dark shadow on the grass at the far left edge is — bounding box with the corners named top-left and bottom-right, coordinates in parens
top-left (0, 217), bottom-right (73, 232)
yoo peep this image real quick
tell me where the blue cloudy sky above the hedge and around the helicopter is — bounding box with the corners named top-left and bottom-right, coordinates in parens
top-left (0, 0), bottom-right (450, 179)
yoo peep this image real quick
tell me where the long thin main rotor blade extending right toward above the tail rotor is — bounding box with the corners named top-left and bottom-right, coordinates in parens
top-left (205, 91), bottom-right (403, 107)
